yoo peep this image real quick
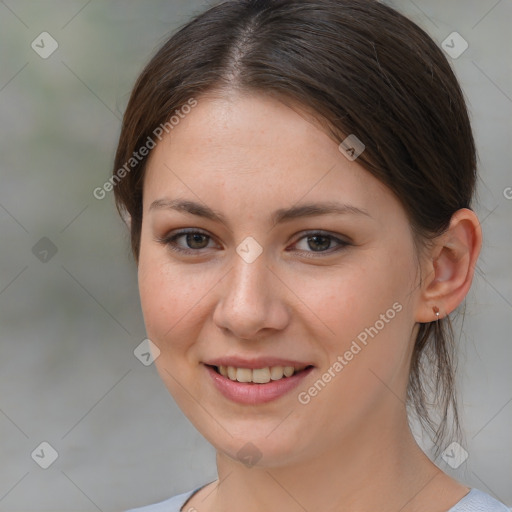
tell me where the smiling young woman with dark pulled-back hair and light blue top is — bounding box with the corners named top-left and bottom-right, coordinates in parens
top-left (112, 0), bottom-right (507, 512)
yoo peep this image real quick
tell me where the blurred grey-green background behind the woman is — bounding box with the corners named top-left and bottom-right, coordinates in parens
top-left (0, 0), bottom-right (512, 511)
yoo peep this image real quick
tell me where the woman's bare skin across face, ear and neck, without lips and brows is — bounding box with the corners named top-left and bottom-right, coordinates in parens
top-left (138, 92), bottom-right (481, 512)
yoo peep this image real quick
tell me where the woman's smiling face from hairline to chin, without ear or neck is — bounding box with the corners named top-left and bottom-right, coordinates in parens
top-left (139, 95), bottom-right (421, 466)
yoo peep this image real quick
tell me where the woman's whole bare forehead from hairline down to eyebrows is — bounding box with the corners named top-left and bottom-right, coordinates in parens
top-left (144, 95), bottom-right (393, 221)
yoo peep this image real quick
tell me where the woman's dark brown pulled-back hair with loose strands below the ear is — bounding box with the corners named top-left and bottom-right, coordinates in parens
top-left (113, 0), bottom-right (476, 454)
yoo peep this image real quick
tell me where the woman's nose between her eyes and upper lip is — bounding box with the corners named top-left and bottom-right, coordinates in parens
top-left (213, 254), bottom-right (290, 340)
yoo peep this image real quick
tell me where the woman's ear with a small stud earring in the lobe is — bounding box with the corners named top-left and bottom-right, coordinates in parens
top-left (416, 208), bottom-right (482, 323)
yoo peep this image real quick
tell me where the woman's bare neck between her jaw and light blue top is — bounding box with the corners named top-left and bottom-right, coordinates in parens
top-left (204, 404), bottom-right (448, 512)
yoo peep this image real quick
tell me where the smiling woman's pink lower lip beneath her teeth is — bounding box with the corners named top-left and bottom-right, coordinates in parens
top-left (205, 365), bottom-right (313, 405)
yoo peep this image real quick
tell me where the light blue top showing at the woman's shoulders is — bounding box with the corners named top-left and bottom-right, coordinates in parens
top-left (127, 484), bottom-right (512, 512)
